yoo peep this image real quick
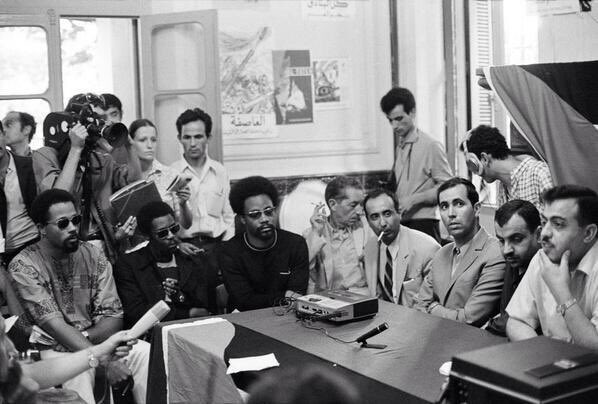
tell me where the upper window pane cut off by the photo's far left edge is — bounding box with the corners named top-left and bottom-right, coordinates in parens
top-left (0, 27), bottom-right (49, 95)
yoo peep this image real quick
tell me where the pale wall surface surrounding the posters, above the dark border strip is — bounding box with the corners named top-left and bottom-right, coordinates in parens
top-left (150, 0), bottom-right (396, 178)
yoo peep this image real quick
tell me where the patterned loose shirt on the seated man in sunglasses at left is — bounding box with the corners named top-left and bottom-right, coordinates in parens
top-left (8, 242), bottom-right (123, 336)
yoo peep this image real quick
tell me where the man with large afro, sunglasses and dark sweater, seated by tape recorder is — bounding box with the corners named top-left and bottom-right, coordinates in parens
top-left (218, 176), bottom-right (309, 311)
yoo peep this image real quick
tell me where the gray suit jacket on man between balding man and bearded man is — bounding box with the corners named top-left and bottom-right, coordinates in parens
top-left (414, 228), bottom-right (505, 327)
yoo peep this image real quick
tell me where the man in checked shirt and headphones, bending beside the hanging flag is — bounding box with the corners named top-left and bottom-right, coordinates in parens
top-left (461, 125), bottom-right (552, 210)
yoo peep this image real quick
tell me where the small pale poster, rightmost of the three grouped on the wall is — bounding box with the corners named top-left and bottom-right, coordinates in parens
top-left (312, 58), bottom-right (349, 109)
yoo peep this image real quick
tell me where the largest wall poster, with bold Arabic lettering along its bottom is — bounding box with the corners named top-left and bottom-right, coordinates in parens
top-left (219, 23), bottom-right (277, 139)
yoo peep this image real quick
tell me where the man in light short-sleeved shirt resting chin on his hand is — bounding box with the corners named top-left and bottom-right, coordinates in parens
top-left (507, 185), bottom-right (598, 350)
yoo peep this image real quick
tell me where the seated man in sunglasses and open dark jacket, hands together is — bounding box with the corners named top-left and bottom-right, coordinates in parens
top-left (114, 201), bottom-right (209, 328)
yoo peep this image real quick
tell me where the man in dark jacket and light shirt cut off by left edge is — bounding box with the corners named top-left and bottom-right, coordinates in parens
top-left (0, 123), bottom-right (39, 265)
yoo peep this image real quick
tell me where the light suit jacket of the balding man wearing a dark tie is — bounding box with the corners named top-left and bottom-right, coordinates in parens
top-left (364, 226), bottom-right (440, 307)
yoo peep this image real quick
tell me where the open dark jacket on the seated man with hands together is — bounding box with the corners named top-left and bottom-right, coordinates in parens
top-left (114, 245), bottom-right (208, 328)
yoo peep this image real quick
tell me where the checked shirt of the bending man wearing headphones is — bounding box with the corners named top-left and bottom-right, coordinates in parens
top-left (498, 156), bottom-right (553, 210)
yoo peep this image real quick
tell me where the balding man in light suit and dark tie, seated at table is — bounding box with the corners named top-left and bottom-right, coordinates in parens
top-left (364, 189), bottom-right (440, 307)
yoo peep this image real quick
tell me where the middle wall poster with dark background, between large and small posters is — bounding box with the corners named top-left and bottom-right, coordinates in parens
top-left (272, 50), bottom-right (314, 125)
